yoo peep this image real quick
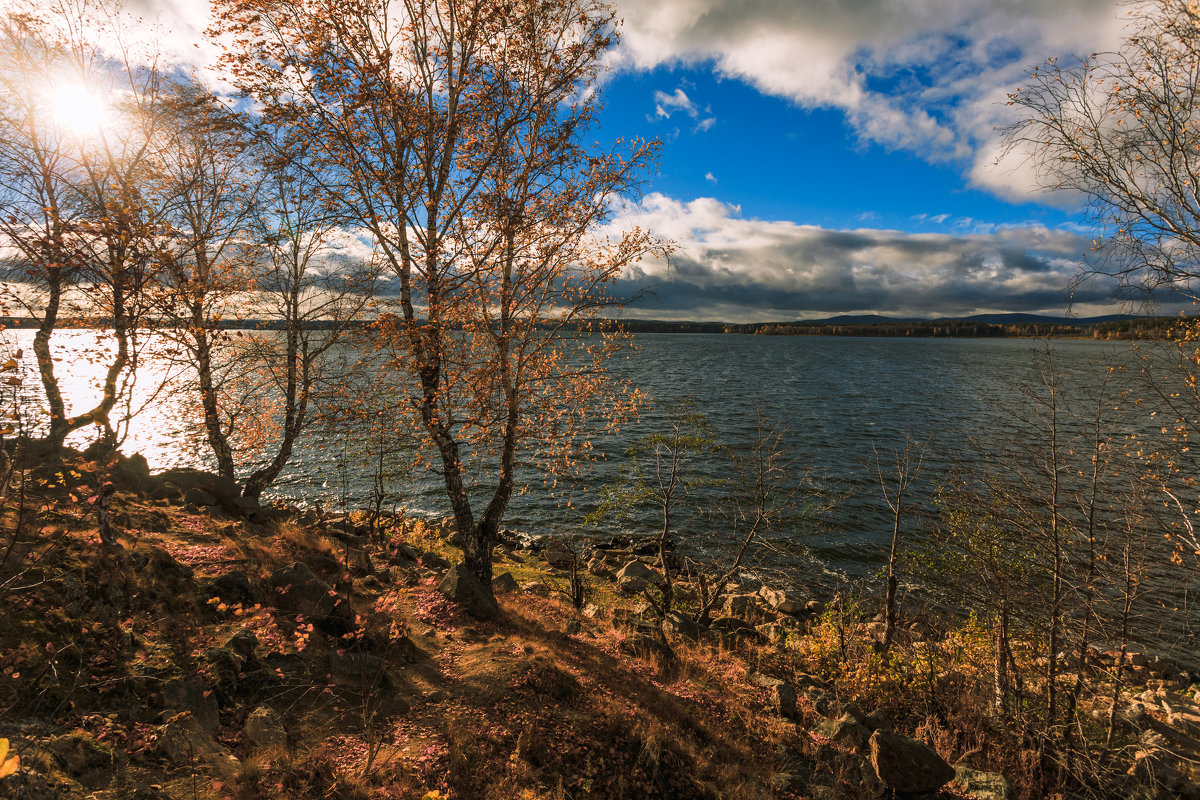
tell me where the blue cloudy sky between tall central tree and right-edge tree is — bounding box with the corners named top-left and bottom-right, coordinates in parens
top-left (144, 0), bottom-right (1142, 321)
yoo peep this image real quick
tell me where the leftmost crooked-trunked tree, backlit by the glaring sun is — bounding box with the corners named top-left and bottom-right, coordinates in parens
top-left (0, 2), bottom-right (169, 447)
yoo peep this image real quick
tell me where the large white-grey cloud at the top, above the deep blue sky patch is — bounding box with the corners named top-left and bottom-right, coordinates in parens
top-left (618, 0), bottom-right (1123, 199)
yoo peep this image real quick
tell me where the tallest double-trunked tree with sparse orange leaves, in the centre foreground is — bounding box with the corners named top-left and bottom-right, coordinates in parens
top-left (214, 0), bottom-right (667, 591)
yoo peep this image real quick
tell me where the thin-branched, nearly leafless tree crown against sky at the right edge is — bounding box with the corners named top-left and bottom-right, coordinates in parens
top-left (1006, 0), bottom-right (1200, 304)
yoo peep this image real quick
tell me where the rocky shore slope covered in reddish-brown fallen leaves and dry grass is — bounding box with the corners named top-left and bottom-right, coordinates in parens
top-left (0, 457), bottom-right (1200, 800)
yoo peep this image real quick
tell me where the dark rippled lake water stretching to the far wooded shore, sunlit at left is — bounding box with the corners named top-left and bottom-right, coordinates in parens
top-left (10, 331), bottom-right (1200, 652)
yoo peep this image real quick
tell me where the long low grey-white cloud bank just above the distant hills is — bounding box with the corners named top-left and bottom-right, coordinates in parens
top-left (613, 194), bottom-right (1112, 320)
